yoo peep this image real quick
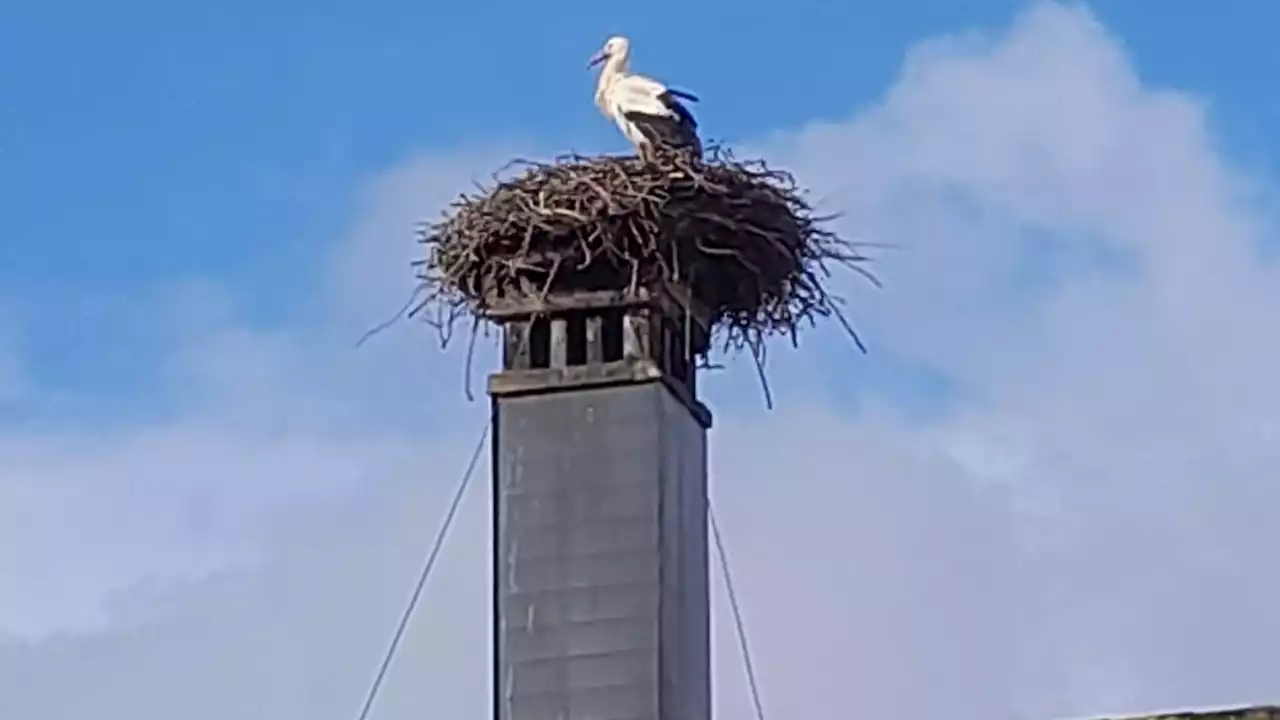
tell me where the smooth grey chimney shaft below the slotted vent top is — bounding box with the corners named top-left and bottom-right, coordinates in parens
top-left (494, 380), bottom-right (710, 720)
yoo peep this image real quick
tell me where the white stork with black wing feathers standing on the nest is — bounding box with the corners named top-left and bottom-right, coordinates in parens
top-left (588, 36), bottom-right (703, 159)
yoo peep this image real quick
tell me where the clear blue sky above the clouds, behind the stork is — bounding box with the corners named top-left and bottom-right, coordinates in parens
top-left (0, 0), bottom-right (1280, 415)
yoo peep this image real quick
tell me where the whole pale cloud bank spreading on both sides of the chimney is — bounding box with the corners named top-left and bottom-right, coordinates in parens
top-left (0, 4), bottom-right (1280, 720)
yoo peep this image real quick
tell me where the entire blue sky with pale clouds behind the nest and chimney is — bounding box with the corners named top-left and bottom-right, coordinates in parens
top-left (0, 0), bottom-right (1280, 720)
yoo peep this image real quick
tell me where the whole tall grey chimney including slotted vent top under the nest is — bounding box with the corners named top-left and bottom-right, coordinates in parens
top-left (489, 284), bottom-right (712, 720)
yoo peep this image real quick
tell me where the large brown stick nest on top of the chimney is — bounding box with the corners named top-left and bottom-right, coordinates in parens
top-left (412, 147), bottom-right (874, 360)
